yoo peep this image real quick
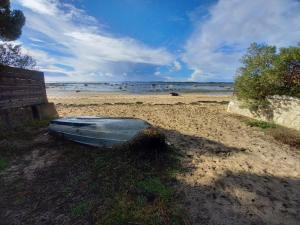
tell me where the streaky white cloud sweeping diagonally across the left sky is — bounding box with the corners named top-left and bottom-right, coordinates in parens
top-left (16, 0), bottom-right (175, 79)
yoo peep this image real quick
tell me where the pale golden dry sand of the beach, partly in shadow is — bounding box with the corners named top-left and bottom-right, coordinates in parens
top-left (49, 93), bottom-right (300, 225)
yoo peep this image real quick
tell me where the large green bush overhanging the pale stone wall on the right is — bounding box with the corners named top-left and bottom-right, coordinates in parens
top-left (235, 43), bottom-right (300, 110)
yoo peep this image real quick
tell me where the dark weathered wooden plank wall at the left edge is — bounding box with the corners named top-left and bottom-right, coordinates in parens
top-left (0, 66), bottom-right (48, 109)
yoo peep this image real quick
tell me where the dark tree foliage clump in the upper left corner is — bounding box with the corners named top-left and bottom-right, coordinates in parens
top-left (0, 0), bottom-right (25, 41)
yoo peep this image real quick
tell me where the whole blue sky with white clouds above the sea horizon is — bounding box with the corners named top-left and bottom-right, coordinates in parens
top-left (12, 0), bottom-right (300, 82)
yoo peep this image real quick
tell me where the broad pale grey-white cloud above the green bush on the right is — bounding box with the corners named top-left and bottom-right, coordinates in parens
top-left (182, 0), bottom-right (300, 81)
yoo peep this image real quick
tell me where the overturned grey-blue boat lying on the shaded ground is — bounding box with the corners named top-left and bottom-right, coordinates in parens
top-left (49, 117), bottom-right (151, 148)
